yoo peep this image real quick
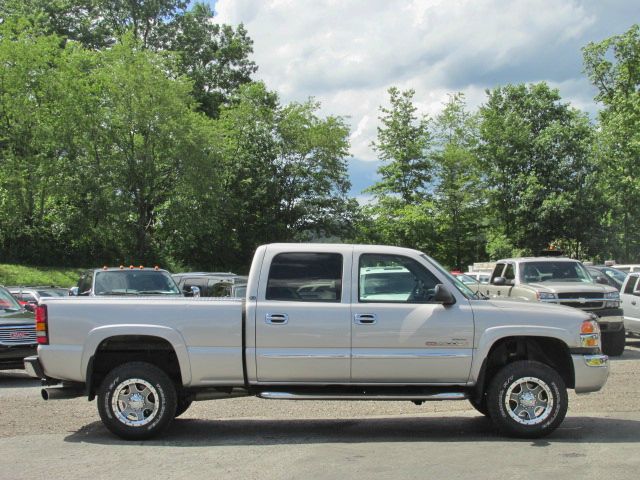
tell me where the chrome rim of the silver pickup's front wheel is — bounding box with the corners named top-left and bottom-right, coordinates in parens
top-left (504, 377), bottom-right (554, 425)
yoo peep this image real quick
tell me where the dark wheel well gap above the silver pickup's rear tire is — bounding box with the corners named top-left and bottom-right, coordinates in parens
top-left (87, 335), bottom-right (182, 400)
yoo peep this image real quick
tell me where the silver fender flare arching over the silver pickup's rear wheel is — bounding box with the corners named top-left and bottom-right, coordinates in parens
top-left (80, 325), bottom-right (191, 386)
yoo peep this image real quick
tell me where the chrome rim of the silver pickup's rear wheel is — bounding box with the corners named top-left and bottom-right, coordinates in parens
top-left (111, 378), bottom-right (160, 427)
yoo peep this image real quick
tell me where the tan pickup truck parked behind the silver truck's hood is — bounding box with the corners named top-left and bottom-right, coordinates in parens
top-left (479, 257), bottom-right (625, 356)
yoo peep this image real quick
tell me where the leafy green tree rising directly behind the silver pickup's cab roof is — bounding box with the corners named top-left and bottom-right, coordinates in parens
top-left (161, 83), bottom-right (354, 268)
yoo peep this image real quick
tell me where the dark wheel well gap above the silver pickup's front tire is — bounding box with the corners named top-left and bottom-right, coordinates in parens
top-left (476, 337), bottom-right (575, 397)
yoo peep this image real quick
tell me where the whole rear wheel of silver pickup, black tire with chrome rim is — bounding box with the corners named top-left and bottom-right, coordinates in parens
top-left (98, 362), bottom-right (177, 440)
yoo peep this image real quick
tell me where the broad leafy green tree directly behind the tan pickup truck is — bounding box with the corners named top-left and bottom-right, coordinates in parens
top-left (478, 83), bottom-right (599, 254)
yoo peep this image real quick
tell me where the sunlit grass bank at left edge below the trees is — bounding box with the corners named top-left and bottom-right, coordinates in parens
top-left (0, 263), bottom-right (86, 288)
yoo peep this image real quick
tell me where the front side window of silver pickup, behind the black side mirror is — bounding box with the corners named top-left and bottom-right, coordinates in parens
top-left (358, 254), bottom-right (440, 303)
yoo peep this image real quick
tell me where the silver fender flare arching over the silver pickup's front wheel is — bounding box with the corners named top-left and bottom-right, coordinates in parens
top-left (470, 325), bottom-right (576, 382)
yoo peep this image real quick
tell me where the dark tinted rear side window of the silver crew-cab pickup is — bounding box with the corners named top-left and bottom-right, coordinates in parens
top-left (266, 252), bottom-right (342, 302)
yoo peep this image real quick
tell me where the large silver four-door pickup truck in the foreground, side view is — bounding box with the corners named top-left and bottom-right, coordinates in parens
top-left (25, 244), bottom-right (608, 439)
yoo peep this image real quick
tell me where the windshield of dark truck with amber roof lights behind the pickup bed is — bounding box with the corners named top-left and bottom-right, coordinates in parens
top-left (94, 270), bottom-right (181, 295)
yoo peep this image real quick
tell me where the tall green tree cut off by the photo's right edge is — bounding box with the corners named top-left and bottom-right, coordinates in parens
top-left (583, 24), bottom-right (640, 261)
